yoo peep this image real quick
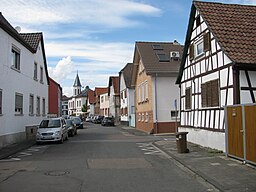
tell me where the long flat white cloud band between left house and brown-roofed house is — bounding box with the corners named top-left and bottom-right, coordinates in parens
top-left (45, 41), bottom-right (134, 64)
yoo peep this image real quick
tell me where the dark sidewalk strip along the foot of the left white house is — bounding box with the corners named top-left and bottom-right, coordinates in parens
top-left (0, 140), bottom-right (35, 159)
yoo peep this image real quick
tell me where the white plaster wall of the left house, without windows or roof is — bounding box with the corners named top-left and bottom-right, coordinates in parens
top-left (0, 24), bottom-right (48, 147)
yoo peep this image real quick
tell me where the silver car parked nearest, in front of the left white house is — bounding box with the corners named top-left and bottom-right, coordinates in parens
top-left (36, 118), bottom-right (68, 143)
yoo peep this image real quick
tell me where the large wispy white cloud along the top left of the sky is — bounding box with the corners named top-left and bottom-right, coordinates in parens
top-left (1, 0), bottom-right (161, 28)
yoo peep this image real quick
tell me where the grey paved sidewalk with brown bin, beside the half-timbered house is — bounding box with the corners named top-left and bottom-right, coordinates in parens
top-left (154, 136), bottom-right (256, 192)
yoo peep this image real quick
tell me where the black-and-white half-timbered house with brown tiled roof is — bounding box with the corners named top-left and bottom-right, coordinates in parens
top-left (176, 1), bottom-right (256, 151)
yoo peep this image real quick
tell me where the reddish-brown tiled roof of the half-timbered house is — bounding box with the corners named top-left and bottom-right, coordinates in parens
top-left (194, 1), bottom-right (256, 64)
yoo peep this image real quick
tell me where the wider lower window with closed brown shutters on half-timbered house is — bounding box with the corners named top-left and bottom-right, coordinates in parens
top-left (201, 79), bottom-right (219, 107)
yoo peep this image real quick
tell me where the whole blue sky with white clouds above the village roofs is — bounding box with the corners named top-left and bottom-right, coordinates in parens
top-left (0, 0), bottom-right (256, 96)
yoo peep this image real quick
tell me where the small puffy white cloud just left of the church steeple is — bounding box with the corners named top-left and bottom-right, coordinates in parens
top-left (48, 56), bottom-right (74, 83)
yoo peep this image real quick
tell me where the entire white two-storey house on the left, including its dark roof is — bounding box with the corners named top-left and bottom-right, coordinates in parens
top-left (0, 13), bottom-right (48, 147)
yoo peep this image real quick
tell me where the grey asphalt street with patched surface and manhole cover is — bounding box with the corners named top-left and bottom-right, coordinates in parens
top-left (0, 123), bottom-right (213, 192)
